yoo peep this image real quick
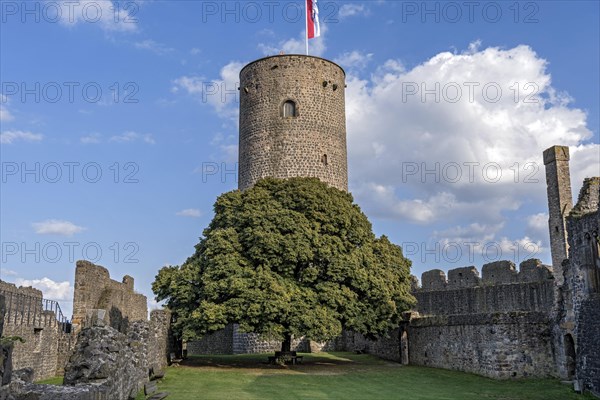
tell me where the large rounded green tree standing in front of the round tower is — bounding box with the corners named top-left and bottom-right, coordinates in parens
top-left (152, 178), bottom-right (414, 351)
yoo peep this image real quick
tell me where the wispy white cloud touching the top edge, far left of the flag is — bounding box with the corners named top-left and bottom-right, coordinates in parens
top-left (53, 0), bottom-right (141, 33)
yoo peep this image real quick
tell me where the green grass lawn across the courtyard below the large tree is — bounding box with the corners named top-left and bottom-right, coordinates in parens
top-left (146, 353), bottom-right (592, 400)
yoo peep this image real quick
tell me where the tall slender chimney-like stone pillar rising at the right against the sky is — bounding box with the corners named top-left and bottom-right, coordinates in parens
top-left (544, 146), bottom-right (573, 285)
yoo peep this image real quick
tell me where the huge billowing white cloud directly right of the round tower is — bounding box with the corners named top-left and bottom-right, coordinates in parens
top-left (346, 42), bottom-right (600, 225)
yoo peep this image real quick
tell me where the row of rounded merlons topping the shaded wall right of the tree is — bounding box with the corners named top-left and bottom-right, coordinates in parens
top-left (420, 259), bottom-right (552, 291)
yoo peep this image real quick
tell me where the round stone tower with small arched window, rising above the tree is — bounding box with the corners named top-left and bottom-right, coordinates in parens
top-left (239, 55), bottom-right (348, 191)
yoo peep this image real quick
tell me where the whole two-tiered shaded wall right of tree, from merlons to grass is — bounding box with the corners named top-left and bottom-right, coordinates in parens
top-left (407, 260), bottom-right (556, 379)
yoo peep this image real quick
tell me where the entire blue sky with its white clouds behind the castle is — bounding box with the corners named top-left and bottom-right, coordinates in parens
top-left (0, 0), bottom-right (600, 318)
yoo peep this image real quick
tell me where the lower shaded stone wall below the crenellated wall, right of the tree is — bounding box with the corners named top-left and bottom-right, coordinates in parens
top-left (408, 312), bottom-right (555, 379)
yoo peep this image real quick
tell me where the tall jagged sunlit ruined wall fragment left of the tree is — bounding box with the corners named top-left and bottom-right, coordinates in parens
top-left (73, 261), bottom-right (148, 330)
